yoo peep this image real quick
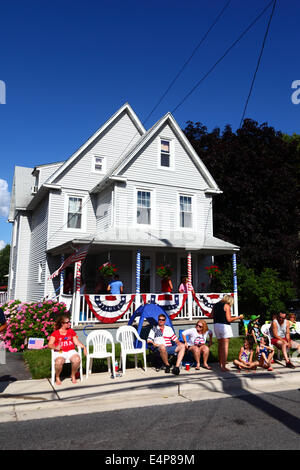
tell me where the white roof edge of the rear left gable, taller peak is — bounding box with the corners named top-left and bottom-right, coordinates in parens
top-left (46, 103), bottom-right (146, 184)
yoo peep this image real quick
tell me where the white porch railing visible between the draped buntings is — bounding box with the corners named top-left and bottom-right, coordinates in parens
top-left (60, 292), bottom-right (234, 326)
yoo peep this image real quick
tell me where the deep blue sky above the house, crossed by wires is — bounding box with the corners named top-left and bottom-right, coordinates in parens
top-left (0, 0), bottom-right (300, 248)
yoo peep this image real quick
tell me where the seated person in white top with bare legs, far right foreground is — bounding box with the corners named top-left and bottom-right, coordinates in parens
top-left (270, 312), bottom-right (300, 369)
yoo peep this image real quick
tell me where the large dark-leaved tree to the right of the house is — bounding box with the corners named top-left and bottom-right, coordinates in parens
top-left (184, 119), bottom-right (300, 285)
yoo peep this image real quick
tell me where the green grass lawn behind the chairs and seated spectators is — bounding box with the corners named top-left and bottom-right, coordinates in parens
top-left (23, 337), bottom-right (243, 379)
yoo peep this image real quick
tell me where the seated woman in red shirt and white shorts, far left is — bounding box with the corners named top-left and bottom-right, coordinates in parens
top-left (48, 315), bottom-right (87, 385)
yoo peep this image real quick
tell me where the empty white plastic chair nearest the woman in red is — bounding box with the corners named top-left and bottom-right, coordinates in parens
top-left (86, 330), bottom-right (116, 378)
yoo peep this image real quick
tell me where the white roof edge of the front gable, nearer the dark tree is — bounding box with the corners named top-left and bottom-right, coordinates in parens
top-left (91, 112), bottom-right (222, 194)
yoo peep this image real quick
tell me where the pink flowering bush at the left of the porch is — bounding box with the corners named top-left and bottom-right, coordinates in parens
top-left (1, 300), bottom-right (67, 352)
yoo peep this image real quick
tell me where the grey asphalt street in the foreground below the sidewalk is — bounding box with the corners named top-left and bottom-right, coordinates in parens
top-left (0, 389), bottom-right (300, 452)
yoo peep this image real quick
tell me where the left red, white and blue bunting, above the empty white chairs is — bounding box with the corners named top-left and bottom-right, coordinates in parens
top-left (85, 294), bottom-right (135, 323)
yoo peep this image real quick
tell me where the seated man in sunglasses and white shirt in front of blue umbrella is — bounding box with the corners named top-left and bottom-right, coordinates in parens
top-left (147, 313), bottom-right (185, 375)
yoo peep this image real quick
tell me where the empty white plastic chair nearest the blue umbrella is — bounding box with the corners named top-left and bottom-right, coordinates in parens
top-left (116, 325), bottom-right (147, 375)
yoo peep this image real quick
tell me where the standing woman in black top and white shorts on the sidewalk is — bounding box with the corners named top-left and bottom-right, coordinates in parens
top-left (212, 295), bottom-right (244, 372)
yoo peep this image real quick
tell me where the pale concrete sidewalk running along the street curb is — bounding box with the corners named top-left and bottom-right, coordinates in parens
top-left (0, 358), bottom-right (300, 422)
